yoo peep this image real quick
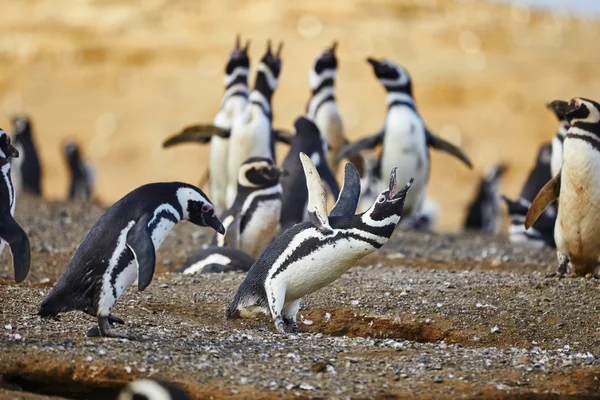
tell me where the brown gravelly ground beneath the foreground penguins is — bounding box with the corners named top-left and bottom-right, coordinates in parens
top-left (0, 198), bottom-right (600, 399)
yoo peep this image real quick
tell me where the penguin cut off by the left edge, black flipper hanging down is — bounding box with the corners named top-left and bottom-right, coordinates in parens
top-left (0, 129), bottom-right (31, 282)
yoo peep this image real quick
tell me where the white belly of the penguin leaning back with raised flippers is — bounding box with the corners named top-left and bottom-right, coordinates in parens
top-left (275, 238), bottom-right (375, 303)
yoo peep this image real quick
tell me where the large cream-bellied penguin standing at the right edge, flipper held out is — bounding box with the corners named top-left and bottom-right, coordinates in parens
top-left (525, 97), bottom-right (600, 276)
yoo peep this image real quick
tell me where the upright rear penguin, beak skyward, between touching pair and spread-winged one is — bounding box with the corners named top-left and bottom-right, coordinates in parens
top-left (306, 42), bottom-right (348, 172)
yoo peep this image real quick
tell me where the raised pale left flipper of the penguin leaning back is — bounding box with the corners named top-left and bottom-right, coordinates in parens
top-left (300, 153), bottom-right (333, 233)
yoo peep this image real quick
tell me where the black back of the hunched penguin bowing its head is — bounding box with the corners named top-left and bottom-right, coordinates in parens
top-left (38, 182), bottom-right (192, 316)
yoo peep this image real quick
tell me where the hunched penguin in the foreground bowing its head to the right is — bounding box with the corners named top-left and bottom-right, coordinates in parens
top-left (38, 182), bottom-right (225, 338)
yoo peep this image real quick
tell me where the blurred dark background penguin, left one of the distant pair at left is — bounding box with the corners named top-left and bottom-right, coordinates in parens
top-left (12, 115), bottom-right (42, 196)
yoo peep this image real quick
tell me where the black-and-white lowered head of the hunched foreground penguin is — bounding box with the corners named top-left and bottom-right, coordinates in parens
top-left (176, 185), bottom-right (225, 235)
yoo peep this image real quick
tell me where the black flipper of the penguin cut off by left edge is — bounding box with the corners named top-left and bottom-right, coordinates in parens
top-left (0, 211), bottom-right (31, 283)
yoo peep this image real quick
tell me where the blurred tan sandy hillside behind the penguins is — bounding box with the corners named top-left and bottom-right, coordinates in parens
top-left (0, 0), bottom-right (600, 230)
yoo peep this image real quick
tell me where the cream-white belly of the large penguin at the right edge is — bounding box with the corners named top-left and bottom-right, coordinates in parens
top-left (555, 138), bottom-right (600, 265)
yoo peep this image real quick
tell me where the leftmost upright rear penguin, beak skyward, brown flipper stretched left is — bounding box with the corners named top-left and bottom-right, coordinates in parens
top-left (163, 35), bottom-right (250, 210)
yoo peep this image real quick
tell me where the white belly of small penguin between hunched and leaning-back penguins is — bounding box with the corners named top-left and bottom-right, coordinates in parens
top-left (241, 199), bottom-right (281, 259)
